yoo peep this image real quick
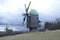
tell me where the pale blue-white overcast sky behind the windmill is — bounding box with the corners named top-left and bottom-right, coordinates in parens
top-left (0, 0), bottom-right (60, 22)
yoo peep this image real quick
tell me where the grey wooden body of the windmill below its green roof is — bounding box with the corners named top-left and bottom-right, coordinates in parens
top-left (27, 14), bottom-right (39, 30)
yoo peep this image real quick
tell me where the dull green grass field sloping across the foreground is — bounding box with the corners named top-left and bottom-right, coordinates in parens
top-left (0, 30), bottom-right (60, 40)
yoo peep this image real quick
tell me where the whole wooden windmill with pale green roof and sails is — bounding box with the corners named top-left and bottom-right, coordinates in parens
top-left (23, 1), bottom-right (39, 31)
